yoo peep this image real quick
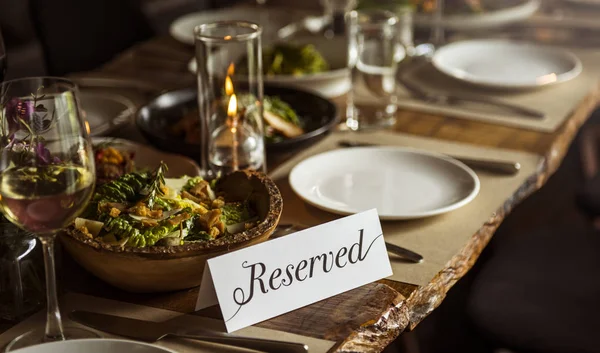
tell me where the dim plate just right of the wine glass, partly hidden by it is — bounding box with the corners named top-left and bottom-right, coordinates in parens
top-left (79, 91), bottom-right (135, 136)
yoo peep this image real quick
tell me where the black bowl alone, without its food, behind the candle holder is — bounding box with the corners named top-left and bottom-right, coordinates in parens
top-left (135, 85), bottom-right (338, 160)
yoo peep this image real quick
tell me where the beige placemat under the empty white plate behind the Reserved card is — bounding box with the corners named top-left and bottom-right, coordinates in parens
top-left (271, 132), bottom-right (542, 285)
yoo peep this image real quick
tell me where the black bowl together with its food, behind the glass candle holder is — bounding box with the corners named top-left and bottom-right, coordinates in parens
top-left (136, 85), bottom-right (338, 159)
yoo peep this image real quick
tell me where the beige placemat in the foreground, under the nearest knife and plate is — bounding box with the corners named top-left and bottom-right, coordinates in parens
top-left (0, 293), bottom-right (335, 353)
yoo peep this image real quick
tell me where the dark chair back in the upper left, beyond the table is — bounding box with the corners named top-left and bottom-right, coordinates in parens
top-left (29, 0), bottom-right (154, 76)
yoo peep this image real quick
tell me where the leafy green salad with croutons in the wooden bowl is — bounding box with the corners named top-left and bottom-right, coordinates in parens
top-left (75, 163), bottom-right (257, 247)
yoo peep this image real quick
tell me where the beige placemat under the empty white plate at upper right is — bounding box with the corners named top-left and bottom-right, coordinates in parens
top-left (366, 49), bottom-right (600, 132)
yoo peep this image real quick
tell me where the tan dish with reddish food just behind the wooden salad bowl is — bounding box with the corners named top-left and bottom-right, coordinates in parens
top-left (92, 137), bottom-right (202, 178)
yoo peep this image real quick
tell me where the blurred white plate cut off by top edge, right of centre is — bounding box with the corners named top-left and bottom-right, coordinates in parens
top-left (415, 0), bottom-right (542, 31)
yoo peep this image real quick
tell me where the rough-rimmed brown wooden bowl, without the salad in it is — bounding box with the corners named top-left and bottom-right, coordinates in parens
top-left (59, 171), bottom-right (283, 293)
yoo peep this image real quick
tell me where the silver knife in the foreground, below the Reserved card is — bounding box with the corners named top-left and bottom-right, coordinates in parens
top-left (69, 310), bottom-right (308, 353)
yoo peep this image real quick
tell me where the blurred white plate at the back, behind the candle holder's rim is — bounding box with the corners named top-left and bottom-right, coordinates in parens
top-left (169, 7), bottom-right (315, 45)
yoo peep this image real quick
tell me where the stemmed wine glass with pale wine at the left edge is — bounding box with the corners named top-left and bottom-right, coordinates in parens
top-left (0, 77), bottom-right (98, 351)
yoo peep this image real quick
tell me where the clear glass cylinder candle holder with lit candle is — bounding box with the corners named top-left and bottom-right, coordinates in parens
top-left (194, 21), bottom-right (266, 177)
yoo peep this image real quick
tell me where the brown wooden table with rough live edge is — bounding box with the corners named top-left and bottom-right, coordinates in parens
top-left (57, 37), bottom-right (600, 352)
